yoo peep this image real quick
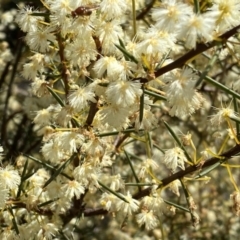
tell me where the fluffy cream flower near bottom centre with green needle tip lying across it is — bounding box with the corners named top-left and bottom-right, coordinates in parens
top-left (117, 192), bottom-right (139, 215)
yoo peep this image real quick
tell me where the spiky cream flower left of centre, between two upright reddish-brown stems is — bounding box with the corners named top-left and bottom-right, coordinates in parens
top-left (68, 87), bottom-right (96, 112)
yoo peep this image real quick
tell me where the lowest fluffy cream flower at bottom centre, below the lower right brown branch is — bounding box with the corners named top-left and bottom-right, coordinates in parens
top-left (136, 210), bottom-right (159, 230)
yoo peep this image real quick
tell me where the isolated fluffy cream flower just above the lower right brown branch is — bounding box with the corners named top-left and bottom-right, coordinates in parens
top-left (163, 147), bottom-right (187, 171)
